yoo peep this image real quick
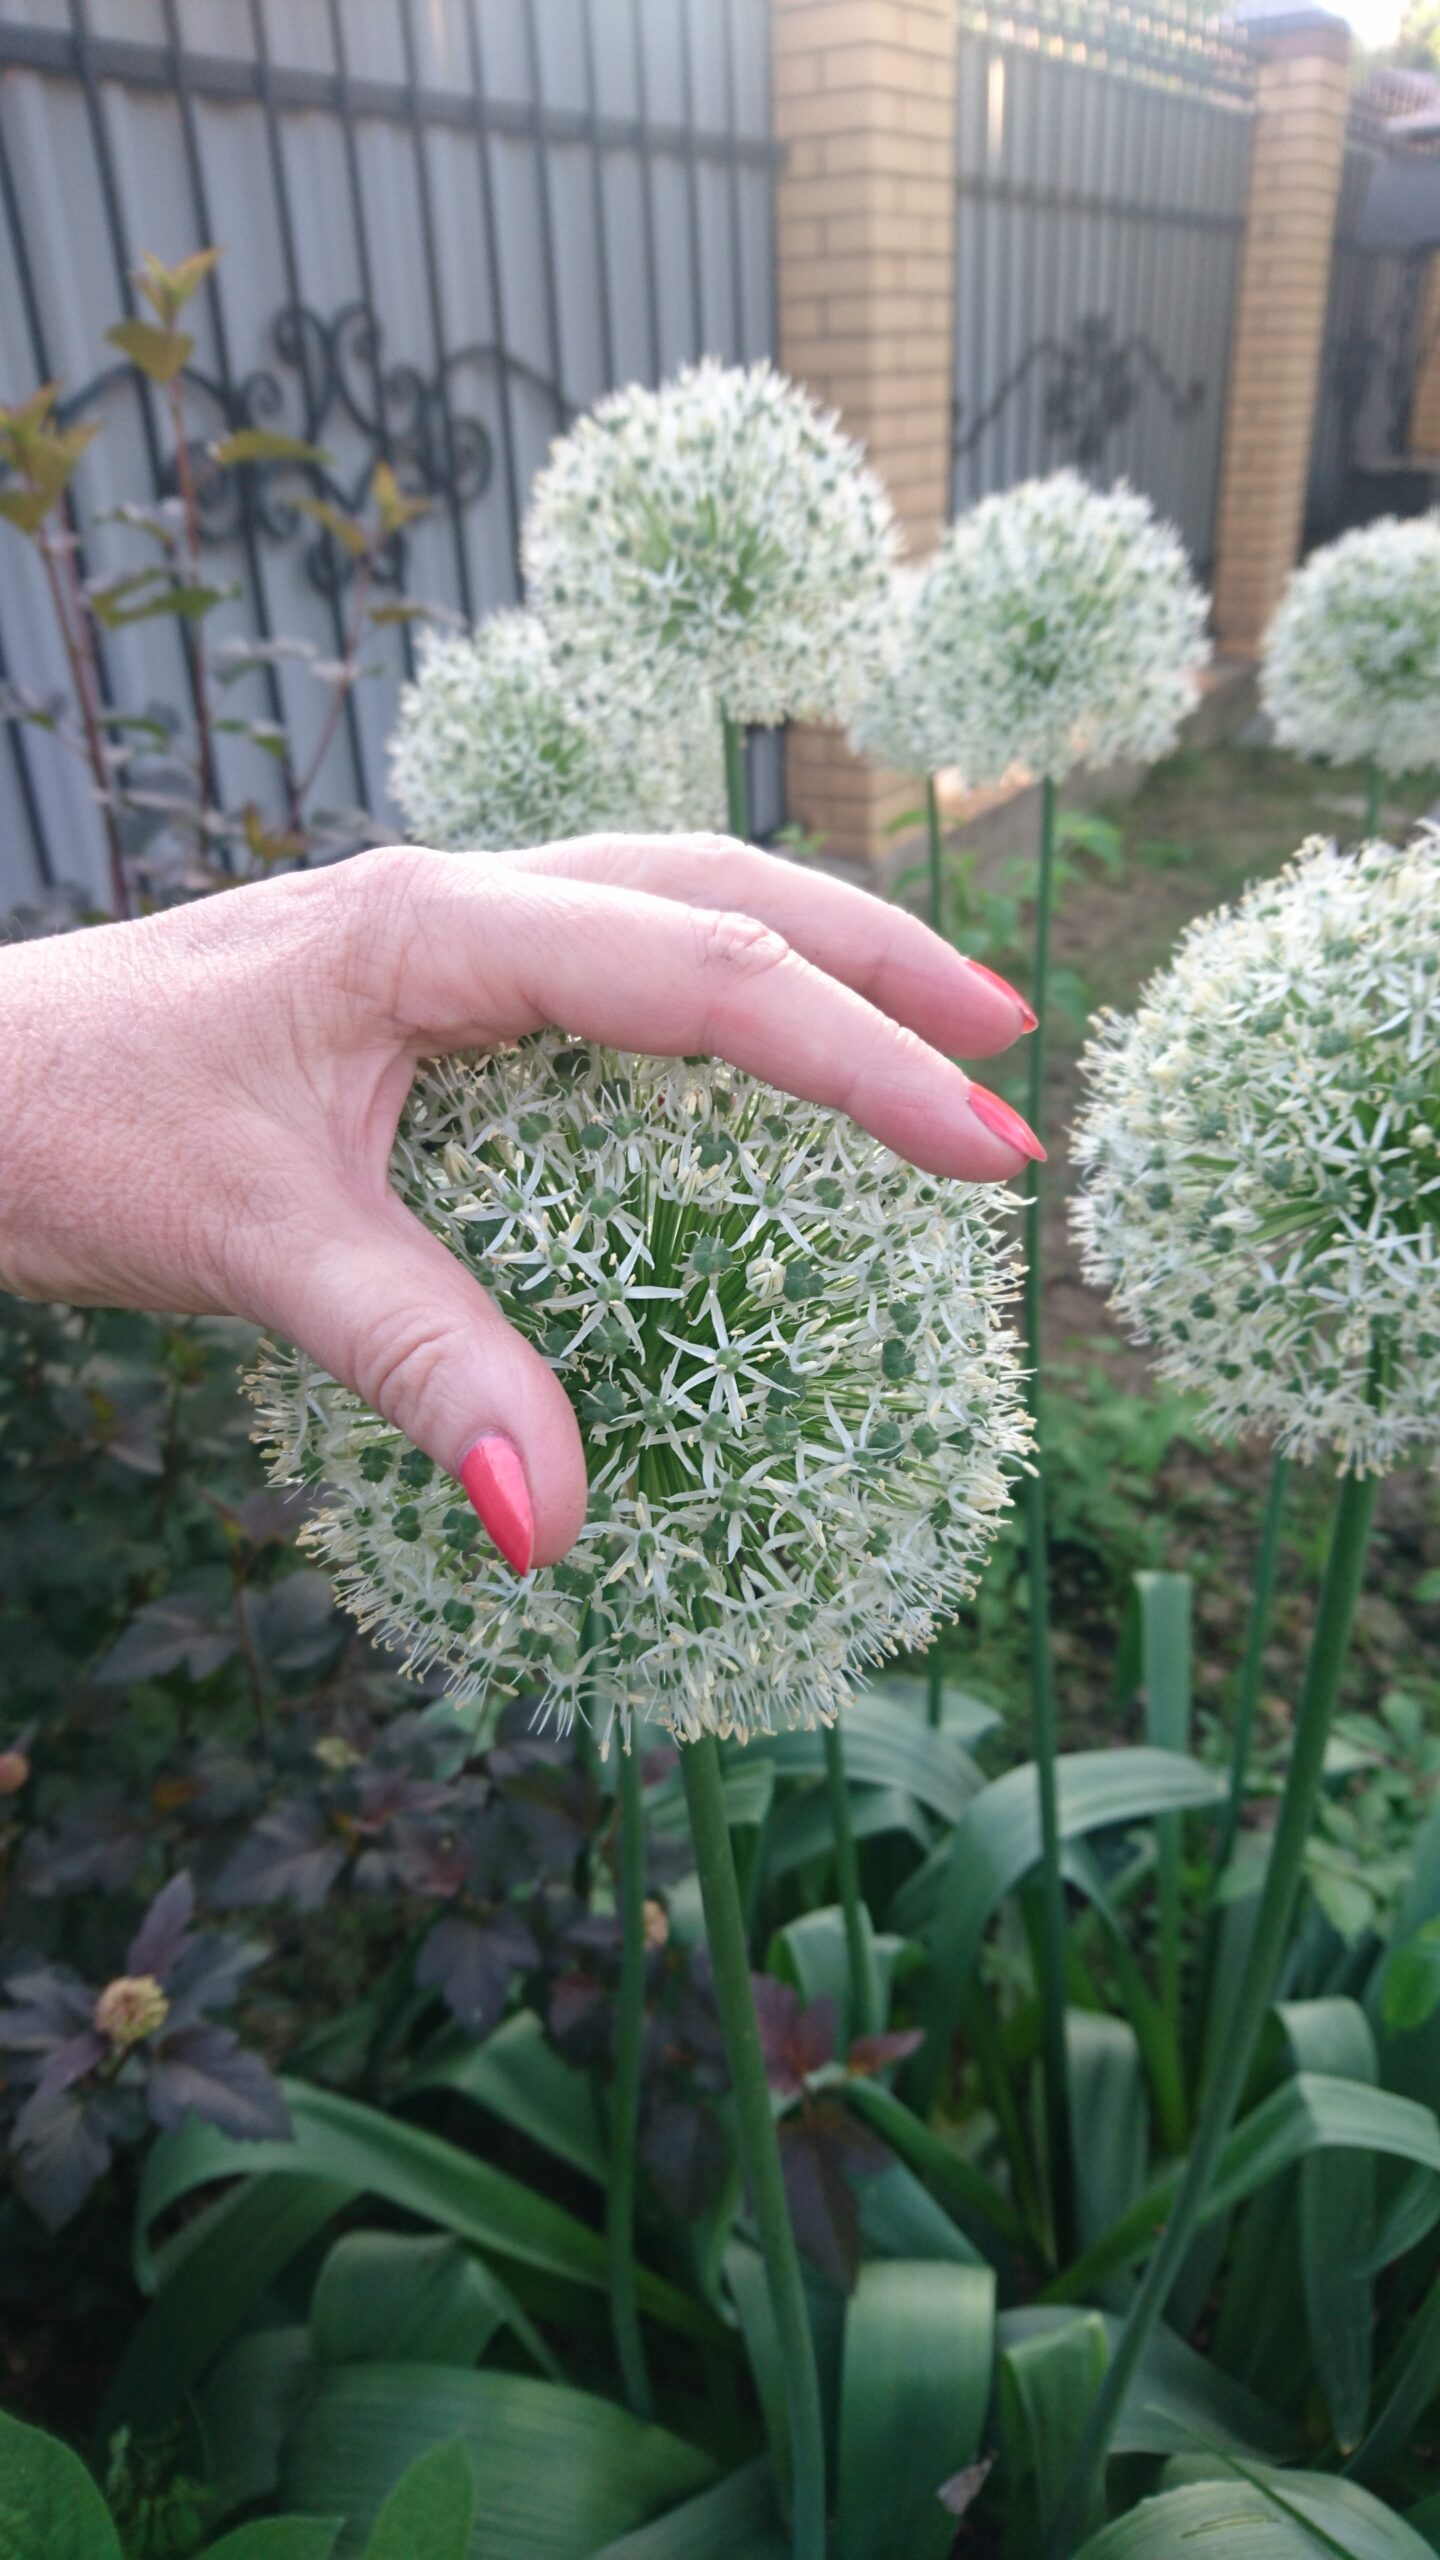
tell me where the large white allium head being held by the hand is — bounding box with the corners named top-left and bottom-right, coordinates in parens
top-left (251, 1032), bottom-right (1027, 1741)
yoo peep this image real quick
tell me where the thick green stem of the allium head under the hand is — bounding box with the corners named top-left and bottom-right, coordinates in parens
top-left (679, 1733), bottom-right (825, 2560)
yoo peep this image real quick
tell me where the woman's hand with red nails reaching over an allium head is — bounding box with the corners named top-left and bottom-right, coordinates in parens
top-left (0, 837), bottom-right (1040, 1569)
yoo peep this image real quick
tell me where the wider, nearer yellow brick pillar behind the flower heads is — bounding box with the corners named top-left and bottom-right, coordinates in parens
top-left (771, 0), bottom-right (956, 860)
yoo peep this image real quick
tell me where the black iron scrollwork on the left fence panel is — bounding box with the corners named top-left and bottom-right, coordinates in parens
top-left (61, 302), bottom-right (571, 594)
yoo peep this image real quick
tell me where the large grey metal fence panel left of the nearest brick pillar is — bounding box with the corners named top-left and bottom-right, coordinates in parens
top-left (0, 0), bottom-right (779, 904)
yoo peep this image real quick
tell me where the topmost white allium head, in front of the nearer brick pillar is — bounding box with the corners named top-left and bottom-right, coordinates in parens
top-left (523, 358), bottom-right (897, 727)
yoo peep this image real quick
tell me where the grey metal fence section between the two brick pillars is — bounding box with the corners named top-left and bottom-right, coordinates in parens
top-left (953, 0), bottom-right (1253, 573)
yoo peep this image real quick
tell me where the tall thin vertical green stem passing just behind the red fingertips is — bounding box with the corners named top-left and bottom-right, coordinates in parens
top-left (1022, 776), bottom-right (1074, 2260)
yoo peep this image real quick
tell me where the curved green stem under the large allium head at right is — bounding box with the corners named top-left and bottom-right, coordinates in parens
top-left (1045, 1475), bottom-right (1376, 2560)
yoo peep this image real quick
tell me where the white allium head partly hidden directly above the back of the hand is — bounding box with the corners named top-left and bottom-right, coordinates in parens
top-left (389, 612), bottom-right (725, 850)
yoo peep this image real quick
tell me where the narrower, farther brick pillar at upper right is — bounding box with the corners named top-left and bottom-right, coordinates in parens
top-left (1215, 8), bottom-right (1350, 658)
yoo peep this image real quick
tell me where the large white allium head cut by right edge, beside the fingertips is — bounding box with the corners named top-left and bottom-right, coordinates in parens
top-left (1074, 832), bottom-right (1440, 1472)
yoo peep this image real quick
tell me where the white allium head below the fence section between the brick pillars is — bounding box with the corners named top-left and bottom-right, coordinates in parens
top-left (902, 471), bottom-right (1209, 786)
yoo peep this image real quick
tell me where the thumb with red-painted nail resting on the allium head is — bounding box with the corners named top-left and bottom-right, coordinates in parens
top-left (266, 1185), bottom-right (587, 1572)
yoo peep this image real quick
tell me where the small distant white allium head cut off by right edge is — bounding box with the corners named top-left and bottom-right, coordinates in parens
top-left (1261, 515), bottom-right (1440, 773)
